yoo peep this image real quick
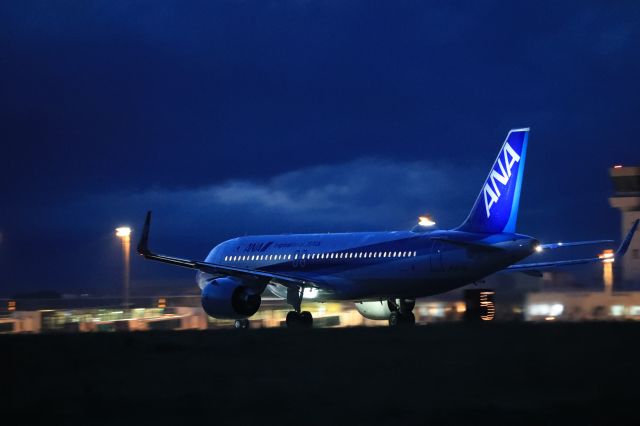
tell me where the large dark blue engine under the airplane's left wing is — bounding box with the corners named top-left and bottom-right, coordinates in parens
top-left (202, 277), bottom-right (264, 319)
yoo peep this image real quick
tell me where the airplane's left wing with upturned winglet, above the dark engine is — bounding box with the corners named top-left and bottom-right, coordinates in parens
top-left (138, 211), bottom-right (320, 288)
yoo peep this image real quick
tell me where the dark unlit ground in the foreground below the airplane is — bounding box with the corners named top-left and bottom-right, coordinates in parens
top-left (5, 323), bottom-right (640, 425)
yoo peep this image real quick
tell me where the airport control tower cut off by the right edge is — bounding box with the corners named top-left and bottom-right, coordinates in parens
top-left (609, 166), bottom-right (640, 284)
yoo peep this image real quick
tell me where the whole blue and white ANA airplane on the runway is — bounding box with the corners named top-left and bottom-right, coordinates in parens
top-left (137, 128), bottom-right (638, 328)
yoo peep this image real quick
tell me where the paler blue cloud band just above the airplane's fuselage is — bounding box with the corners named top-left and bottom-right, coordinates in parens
top-left (48, 158), bottom-right (480, 238)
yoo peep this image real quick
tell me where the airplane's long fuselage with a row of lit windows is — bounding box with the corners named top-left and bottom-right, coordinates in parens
top-left (197, 230), bottom-right (538, 300)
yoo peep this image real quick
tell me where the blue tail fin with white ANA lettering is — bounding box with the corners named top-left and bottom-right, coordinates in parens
top-left (457, 128), bottom-right (529, 234)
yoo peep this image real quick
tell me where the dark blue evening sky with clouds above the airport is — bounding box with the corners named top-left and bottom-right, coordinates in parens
top-left (0, 0), bottom-right (640, 294)
